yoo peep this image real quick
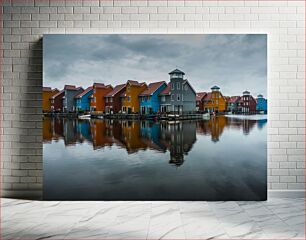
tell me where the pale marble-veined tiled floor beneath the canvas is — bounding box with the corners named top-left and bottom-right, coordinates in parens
top-left (1, 198), bottom-right (305, 239)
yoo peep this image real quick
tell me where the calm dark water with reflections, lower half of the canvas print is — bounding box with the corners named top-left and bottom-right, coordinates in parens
top-left (43, 116), bottom-right (267, 200)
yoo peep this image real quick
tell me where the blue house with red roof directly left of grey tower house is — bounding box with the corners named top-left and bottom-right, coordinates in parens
top-left (139, 81), bottom-right (167, 114)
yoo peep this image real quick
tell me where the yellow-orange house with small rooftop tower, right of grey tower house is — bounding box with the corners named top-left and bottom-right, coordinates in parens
top-left (204, 86), bottom-right (226, 113)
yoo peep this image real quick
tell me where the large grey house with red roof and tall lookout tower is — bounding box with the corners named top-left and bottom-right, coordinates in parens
top-left (159, 69), bottom-right (196, 114)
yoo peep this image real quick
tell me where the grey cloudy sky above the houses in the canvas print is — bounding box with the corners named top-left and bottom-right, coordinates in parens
top-left (43, 34), bottom-right (267, 96)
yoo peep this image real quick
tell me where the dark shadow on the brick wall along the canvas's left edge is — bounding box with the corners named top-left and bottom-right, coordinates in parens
top-left (1, 38), bottom-right (43, 199)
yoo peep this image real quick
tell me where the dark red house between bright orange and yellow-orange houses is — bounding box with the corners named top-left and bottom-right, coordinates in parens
top-left (104, 84), bottom-right (125, 114)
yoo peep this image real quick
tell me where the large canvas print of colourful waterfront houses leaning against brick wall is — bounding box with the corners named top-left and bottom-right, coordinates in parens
top-left (42, 34), bottom-right (268, 201)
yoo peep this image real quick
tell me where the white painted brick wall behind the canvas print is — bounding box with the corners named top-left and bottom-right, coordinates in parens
top-left (1, 0), bottom-right (305, 196)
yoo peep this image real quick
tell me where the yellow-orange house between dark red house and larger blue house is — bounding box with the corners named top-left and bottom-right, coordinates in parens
top-left (121, 80), bottom-right (147, 113)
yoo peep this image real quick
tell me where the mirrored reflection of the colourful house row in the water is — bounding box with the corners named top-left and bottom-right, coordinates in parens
top-left (43, 116), bottom-right (267, 166)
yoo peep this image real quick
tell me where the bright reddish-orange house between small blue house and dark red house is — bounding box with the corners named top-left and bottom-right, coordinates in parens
top-left (90, 83), bottom-right (113, 113)
